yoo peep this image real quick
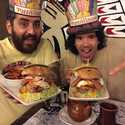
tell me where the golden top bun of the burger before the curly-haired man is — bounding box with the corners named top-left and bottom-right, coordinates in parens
top-left (75, 67), bottom-right (102, 80)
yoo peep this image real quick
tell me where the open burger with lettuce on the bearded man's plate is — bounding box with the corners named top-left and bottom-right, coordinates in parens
top-left (19, 65), bottom-right (59, 102)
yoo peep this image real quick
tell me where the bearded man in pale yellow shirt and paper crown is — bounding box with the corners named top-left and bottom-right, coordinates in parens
top-left (0, 0), bottom-right (57, 125)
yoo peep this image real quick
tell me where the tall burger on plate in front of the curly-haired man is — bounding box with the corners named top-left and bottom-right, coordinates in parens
top-left (69, 67), bottom-right (103, 98)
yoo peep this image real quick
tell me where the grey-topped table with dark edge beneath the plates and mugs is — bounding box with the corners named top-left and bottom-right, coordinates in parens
top-left (11, 95), bottom-right (125, 125)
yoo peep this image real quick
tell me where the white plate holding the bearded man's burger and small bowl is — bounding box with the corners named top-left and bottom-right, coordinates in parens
top-left (0, 75), bottom-right (61, 106)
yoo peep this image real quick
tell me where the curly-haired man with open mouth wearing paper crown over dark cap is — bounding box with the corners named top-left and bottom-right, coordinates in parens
top-left (62, 0), bottom-right (125, 101)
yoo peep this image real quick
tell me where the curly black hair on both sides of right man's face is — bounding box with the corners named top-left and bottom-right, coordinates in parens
top-left (66, 27), bottom-right (107, 55)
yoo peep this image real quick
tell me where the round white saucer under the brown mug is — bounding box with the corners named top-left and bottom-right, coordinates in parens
top-left (59, 106), bottom-right (98, 125)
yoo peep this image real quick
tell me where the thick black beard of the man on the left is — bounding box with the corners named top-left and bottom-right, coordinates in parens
top-left (12, 31), bottom-right (40, 53)
